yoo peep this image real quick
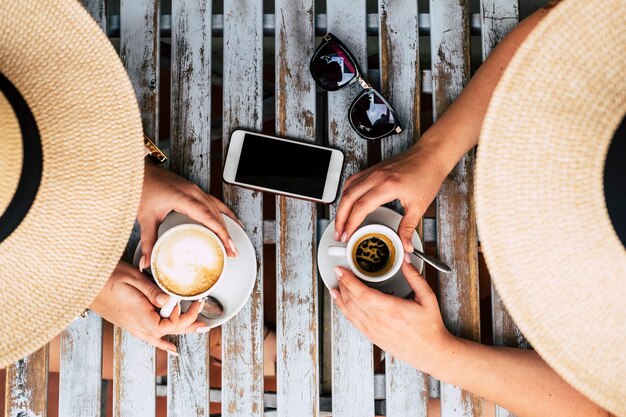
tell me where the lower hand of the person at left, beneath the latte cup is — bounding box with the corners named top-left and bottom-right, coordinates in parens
top-left (90, 262), bottom-right (209, 354)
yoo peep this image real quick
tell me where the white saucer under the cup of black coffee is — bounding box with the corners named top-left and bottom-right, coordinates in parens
top-left (317, 207), bottom-right (424, 298)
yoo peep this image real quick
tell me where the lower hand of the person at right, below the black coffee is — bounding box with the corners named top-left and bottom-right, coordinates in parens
top-left (330, 262), bottom-right (454, 373)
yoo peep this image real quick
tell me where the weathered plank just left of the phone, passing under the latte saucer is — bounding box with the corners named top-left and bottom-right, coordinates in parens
top-left (167, 0), bottom-right (211, 417)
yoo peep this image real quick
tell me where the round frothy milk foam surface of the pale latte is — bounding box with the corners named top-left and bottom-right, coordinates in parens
top-left (152, 228), bottom-right (224, 297)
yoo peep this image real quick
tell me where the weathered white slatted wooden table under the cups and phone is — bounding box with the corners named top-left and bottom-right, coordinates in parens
top-left (5, 0), bottom-right (519, 417)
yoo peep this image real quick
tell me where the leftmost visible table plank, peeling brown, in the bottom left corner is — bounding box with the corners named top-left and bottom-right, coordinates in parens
top-left (4, 345), bottom-right (50, 417)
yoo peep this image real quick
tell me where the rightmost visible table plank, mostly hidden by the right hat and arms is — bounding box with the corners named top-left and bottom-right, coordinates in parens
top-left (480, 0), bottom-right (528, 417)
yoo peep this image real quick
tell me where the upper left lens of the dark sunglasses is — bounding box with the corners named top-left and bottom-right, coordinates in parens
top-left (311, 42), bottom-right (357, 90)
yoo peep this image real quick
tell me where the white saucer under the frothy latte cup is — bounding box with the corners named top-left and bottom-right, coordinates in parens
top-left (133, 212), bottom-right (257, 328)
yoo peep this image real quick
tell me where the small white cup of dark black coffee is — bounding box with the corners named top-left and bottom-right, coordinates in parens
top-left (328, 224), bottom-right (404, 282)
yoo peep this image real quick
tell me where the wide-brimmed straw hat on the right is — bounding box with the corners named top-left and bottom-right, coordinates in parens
top-left (475, 0), bottom-right (626, 415)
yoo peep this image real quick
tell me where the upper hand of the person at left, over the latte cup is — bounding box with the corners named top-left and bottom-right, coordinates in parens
top-left (137, 161), bottom-right (243, 270)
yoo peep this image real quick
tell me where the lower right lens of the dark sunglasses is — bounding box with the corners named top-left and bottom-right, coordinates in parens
top-left (350, 91), bottom-right (400, 139)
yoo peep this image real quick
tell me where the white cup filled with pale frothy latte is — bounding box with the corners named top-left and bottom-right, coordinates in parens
top-left (150, 224), bottom-right (228, 317)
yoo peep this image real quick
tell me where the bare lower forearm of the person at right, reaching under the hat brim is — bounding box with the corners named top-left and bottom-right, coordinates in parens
top-left (431, 338), bottom-right (609, 417)
